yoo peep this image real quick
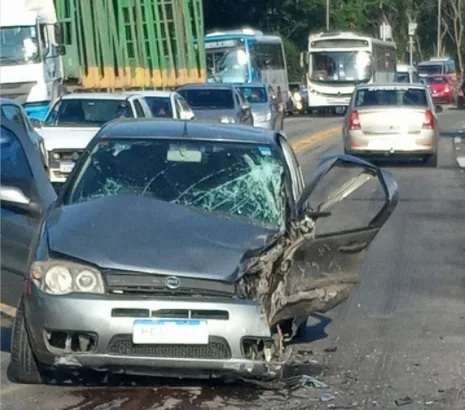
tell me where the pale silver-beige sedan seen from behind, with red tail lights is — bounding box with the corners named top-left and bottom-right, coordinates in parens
top-left (343, 83), bottom-right (442, 167)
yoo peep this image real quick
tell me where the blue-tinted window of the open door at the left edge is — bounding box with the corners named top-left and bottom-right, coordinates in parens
top-left (0, 126), bottom-right (34, 197)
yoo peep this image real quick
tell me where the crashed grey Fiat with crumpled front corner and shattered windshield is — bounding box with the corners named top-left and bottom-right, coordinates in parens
top-left (0, 120), bottom-right (397, 383)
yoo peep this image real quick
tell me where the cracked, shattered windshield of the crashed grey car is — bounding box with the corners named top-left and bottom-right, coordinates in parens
top-left (65, 139), bottom-right (286, 229)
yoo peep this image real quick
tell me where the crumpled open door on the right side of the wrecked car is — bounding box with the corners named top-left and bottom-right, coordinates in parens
top-left (260, 155), bottom-right (398, 325)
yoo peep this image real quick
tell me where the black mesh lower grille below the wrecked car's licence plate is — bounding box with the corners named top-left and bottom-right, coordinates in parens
top-left (108, 335), bottom-right (231, 360)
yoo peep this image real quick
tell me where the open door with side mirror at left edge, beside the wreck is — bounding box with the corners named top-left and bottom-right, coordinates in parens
top-left (0, 116), bottom-right (56, 306)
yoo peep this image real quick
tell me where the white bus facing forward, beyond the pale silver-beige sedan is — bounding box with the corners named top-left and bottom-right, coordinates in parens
top-left (301, 32), bottom-right (397, 112)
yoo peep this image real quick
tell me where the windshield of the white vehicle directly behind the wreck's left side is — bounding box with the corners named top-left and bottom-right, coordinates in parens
top-left (44, 98), bottom-right (134, 127)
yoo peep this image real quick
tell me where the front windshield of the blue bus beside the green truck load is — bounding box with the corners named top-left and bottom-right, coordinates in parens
top-left (205, 43), bottom-right (249, 83)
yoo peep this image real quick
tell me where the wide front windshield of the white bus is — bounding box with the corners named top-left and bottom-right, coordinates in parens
top-left (310, 51), bottom-right (372, 83)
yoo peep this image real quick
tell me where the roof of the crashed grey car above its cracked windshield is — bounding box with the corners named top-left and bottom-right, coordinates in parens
top-left (97, 118), bottom-right (277, 144)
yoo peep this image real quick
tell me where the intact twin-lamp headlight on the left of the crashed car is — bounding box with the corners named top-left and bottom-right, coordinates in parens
top-left (30, 261), bottom-right (105, 295)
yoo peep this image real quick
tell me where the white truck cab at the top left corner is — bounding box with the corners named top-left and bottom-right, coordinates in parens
top-left (0, 0), bottom-right (64, 120)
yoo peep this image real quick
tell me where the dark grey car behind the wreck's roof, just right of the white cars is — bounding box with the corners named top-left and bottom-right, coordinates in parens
top-left (177, 83), bottom-right (253, 125)
